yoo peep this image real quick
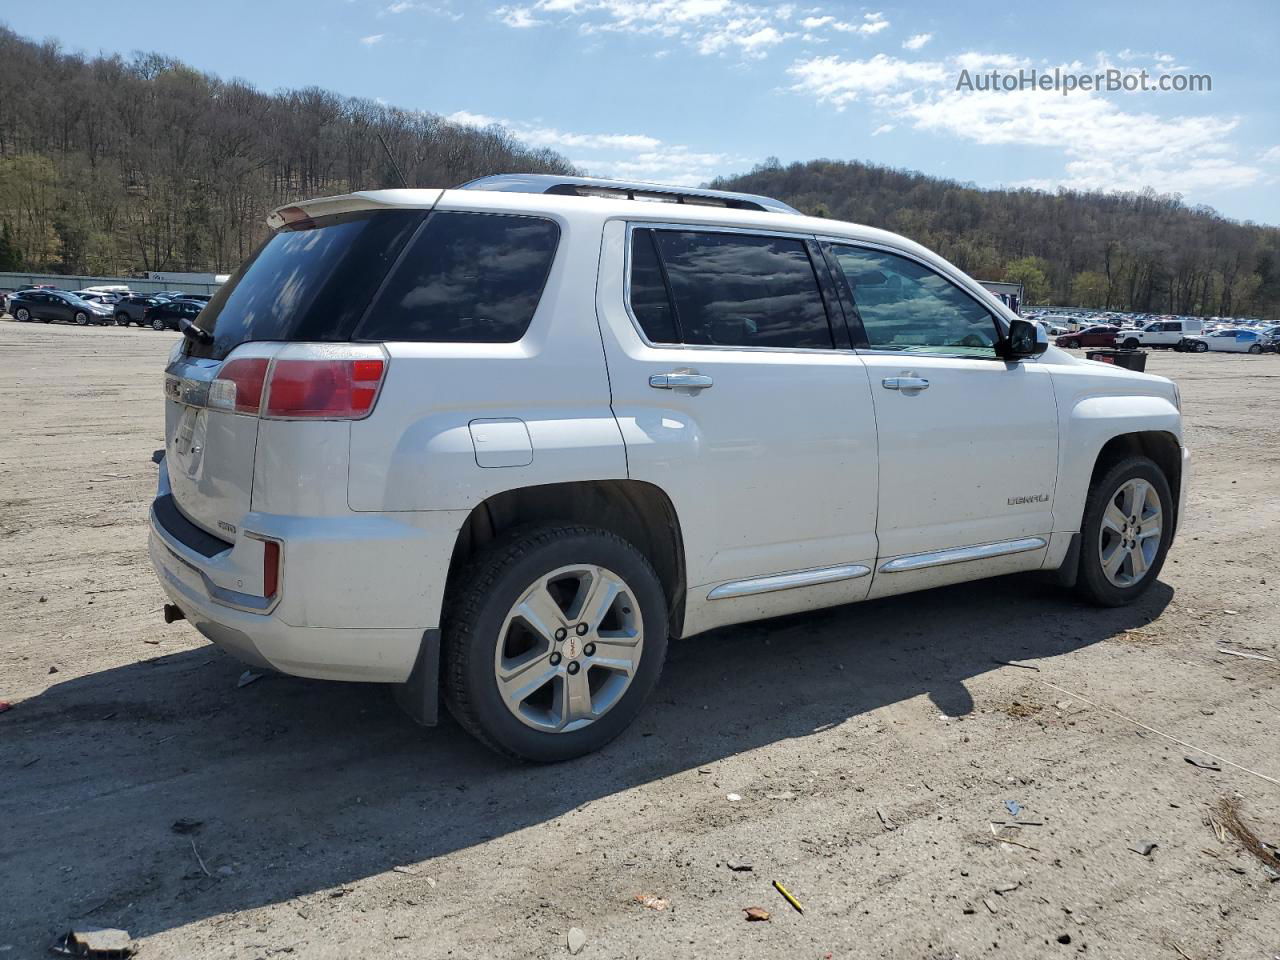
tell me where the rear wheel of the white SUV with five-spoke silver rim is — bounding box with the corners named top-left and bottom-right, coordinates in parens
top-left (442, 526), bottom-right (667, 763)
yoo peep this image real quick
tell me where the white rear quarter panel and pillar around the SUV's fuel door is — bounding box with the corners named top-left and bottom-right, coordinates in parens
top-left (347, 199), bottom-right (627, 512)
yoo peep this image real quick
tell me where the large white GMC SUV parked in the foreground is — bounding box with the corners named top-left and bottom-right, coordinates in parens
top-left (150, 175), bottom-right (1188, 760)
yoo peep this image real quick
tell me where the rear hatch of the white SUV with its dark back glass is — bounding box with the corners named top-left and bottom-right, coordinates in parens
top-left (165, 191), bottom-right (439, 541)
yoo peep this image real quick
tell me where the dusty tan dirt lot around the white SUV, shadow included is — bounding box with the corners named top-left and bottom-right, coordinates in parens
top-left (0, 321), bottom-right (1280, 960)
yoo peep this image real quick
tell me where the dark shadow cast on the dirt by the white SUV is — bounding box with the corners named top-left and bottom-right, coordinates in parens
top-left (0, 577), bottom-right (1172, 948)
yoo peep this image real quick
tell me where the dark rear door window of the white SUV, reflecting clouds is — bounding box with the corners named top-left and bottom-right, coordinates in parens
top-left (631, 229), bottom-right (835, 349)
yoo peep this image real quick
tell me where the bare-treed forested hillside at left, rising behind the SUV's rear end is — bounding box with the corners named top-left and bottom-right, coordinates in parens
top-left (0, 27), bottom-right (572, 275)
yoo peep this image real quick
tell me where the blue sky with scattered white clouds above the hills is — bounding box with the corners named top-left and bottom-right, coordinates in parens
top-left (10, 0), bottom-right (1280, 224)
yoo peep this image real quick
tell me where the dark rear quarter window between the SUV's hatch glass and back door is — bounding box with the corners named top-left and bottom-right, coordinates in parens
top-left (356, 212), bottom-right (559, 343)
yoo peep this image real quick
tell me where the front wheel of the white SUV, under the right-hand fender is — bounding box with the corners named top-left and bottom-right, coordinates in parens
top-left (1076, 457), bottom-right (1174, 607)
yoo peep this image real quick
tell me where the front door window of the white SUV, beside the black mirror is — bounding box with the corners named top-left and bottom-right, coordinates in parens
top-left (831, 246), bottom-right (998, 357)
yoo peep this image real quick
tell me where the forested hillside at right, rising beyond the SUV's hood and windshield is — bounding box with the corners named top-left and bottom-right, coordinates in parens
top-left (713, 160), bottom-right (1280, 319)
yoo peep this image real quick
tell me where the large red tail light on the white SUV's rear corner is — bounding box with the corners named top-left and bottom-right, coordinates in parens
top-left (209, 347), bottom-right (387, 420)
